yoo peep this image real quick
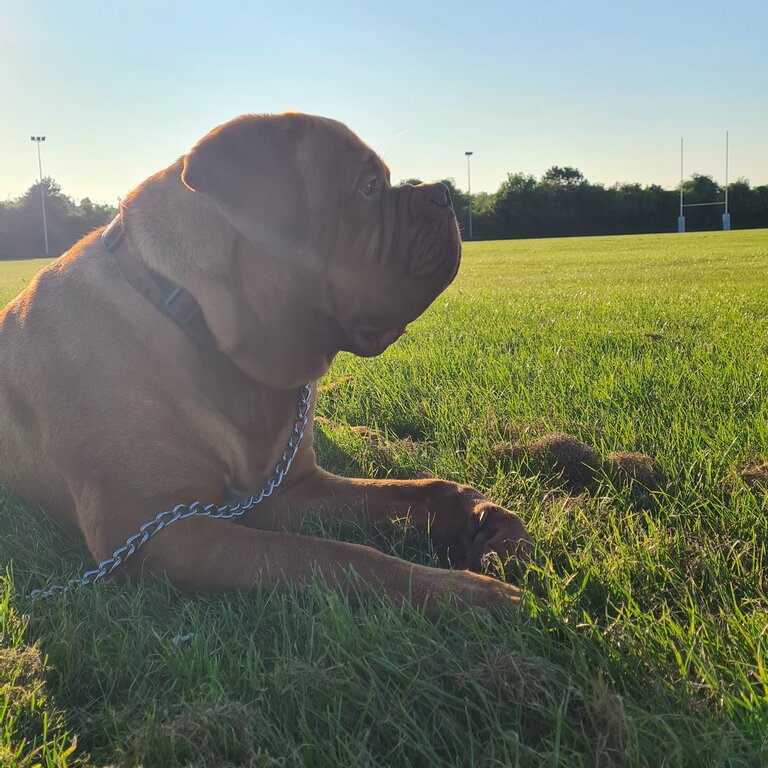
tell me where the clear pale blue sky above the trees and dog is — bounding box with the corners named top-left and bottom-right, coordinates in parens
top-left (0, 0), bottom-right (768, 202)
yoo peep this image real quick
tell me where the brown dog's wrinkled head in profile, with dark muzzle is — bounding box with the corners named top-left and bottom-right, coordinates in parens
top-left (182, 113), bottom-right (461, 356)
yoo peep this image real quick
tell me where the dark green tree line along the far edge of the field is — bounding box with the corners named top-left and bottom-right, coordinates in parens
top-left (0, 166), bottom-right (768, 259)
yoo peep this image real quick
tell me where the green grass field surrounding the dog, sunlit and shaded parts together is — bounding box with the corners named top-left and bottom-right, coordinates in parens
top-left (0, 231), bottom-right (768, 767)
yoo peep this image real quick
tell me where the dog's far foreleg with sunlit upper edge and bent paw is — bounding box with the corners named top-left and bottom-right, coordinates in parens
top-left (246, 469), bottom-right (531, 570)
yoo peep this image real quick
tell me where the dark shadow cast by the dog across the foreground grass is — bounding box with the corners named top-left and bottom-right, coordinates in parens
top-left (0, 462), bottom-right (751, 766)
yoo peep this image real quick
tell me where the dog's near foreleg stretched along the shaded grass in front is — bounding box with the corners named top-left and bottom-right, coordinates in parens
top-left (75, 498), bottom-right (519, 615)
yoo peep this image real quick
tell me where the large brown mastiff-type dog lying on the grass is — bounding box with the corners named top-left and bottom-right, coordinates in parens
top-left (0, 114), bottom-right (528, 605)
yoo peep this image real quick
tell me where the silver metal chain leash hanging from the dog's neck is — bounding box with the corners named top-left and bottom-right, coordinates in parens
top-left (29, 384), bottom-right (312, 598)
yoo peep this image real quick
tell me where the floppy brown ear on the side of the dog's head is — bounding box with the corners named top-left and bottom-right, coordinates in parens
top-left (181, 114), bottom-right (309, 244)
